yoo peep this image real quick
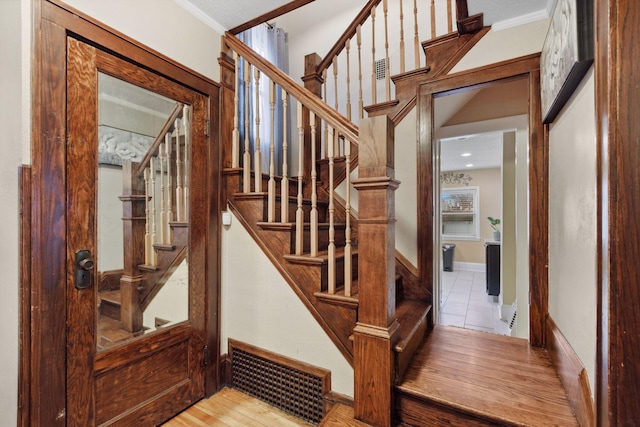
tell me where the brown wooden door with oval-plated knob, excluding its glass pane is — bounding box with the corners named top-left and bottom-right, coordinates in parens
top-left (66, 37), bottom-right (208, 426)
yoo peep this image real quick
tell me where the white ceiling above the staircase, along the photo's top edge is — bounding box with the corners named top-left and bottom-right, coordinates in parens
top-left (175, 0), bottom-right (556, 31)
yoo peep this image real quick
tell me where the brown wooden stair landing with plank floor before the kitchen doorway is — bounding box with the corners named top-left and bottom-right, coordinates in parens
top-left (396, 326), bottom-right (578, 426)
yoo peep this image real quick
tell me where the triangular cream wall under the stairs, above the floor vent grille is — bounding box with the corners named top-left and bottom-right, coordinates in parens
top-left (221, 212), bottom-right (353, 396)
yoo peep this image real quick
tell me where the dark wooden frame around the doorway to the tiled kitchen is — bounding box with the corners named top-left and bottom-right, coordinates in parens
top-left (417, 53), bottom-right (549, 347)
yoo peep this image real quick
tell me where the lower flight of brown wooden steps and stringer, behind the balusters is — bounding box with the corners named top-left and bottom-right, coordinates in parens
top-left (225, 169), bottom-right (431, 372)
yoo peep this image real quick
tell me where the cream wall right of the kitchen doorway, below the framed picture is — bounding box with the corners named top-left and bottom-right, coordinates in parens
top-left (549, 67), bottom-right (598, 392)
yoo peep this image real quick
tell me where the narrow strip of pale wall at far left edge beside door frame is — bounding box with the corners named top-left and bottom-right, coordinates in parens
top-left (0, 0), bottom-right (29, 425)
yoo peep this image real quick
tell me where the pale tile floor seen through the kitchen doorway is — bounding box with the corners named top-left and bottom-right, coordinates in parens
top-left (439, 270), bottom-right (511, 335)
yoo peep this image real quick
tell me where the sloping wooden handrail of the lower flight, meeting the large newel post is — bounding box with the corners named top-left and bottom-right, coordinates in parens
top-left (225, 31), bottom-right (359, 144)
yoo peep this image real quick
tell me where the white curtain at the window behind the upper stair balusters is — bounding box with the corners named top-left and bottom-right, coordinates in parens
top-left (238, 24), bottom-right (289, 174)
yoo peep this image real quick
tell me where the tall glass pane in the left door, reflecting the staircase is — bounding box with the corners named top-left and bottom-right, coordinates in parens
top-left (96, 73), bottom-right (190, 351)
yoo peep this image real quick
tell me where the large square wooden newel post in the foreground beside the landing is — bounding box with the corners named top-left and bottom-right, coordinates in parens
top-left (353, 116), bottom-right (399, 427)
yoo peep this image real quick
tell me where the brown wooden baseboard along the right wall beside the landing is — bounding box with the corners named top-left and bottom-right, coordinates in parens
top-left (546, 316), bottom-right (596, 427)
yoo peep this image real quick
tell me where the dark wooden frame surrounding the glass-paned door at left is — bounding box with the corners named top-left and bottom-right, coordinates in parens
top-left (19, 0), bottom-right (221, 426)
